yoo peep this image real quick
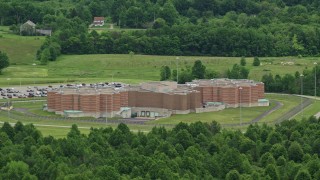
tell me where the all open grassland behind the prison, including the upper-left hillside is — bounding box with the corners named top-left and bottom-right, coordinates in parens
top-left (0, 26), bottom-right (320, 86)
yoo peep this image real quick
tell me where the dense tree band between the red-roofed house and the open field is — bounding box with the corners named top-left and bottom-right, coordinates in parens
top-left (35, 21), bottom-right (320, 57)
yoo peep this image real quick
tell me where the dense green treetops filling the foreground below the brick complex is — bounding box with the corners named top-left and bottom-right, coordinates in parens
top-left (0, 117), bottom-right (320, 180)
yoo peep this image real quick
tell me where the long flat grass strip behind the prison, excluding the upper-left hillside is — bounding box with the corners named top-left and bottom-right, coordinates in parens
top-left (0, 54), bottom-right (320, 85)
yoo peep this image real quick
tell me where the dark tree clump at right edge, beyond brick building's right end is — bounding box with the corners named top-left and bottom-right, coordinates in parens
top-left (261, 65), bottom-right (320, 96)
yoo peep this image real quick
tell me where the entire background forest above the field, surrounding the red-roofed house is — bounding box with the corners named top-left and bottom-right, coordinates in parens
top-left (0, 0), bottom-right (320, 60)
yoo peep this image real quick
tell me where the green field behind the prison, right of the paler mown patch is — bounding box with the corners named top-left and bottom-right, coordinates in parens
top-left (47, 54), bottom-right (320, 81)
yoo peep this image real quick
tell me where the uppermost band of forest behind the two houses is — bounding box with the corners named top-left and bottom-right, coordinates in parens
top-left (0, 0), bottom-right (320, 28)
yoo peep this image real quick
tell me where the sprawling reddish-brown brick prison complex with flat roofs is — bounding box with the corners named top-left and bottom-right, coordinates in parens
top-left (48, 79), bottom-right (269, 118)
